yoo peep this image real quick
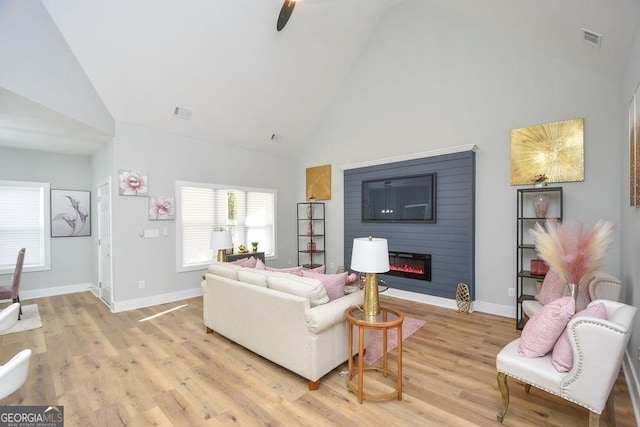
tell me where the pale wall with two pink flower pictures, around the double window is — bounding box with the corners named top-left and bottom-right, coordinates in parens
top-left (110, 123), bottom-right (304, 311)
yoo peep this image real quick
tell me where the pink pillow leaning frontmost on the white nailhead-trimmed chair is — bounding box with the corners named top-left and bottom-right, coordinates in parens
top-left (518, 297), bottom-right (576, 357)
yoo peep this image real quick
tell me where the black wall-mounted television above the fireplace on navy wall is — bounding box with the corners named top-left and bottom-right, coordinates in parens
top-left (362, 172), bottom-right (436, 223)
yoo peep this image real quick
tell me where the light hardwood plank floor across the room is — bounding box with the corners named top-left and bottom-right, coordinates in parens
top-left (0, 292), bottom-right (636, 427)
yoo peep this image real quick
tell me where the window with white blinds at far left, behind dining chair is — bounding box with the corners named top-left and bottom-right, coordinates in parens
top-left (0, 180), bottom-right (51, 274)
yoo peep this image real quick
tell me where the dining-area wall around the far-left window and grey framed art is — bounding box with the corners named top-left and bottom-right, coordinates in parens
top-left (0, 147), bottom-right (95, 299)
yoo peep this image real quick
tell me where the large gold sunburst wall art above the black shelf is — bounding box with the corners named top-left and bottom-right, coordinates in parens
top-left (511, 119), bottom-right (584, 185)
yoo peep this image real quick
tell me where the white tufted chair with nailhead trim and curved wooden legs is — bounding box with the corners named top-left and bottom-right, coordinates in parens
top-left (496, 300), bottom-right (637, 426)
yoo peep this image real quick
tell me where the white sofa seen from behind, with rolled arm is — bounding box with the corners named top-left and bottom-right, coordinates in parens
top-left (202, 262), bottom-right (364, 390)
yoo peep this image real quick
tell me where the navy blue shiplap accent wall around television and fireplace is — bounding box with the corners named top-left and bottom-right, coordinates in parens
top-left (344, 151), bottom-right (476, 300)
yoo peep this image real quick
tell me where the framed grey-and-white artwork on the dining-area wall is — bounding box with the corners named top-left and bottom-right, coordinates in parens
top-left (51, 190), bottom-right (91, 237)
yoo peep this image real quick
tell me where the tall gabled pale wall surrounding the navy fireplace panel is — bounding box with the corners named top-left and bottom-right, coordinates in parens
top-left (298, 0), bottom-right (623, 314)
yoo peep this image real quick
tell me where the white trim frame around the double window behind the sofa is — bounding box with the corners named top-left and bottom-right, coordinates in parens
top-left (175, 181), bottom-right (278, 273)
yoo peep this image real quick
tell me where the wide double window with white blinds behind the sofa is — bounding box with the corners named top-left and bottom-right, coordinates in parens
top-left (176, 181), bottom-right (276, 271)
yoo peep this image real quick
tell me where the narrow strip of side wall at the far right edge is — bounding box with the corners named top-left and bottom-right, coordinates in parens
top-left (619, 19), bottom-right (640, 413)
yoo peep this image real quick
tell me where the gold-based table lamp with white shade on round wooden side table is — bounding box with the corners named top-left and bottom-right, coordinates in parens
top-left (351, 236), bottom-right (389, 318)
